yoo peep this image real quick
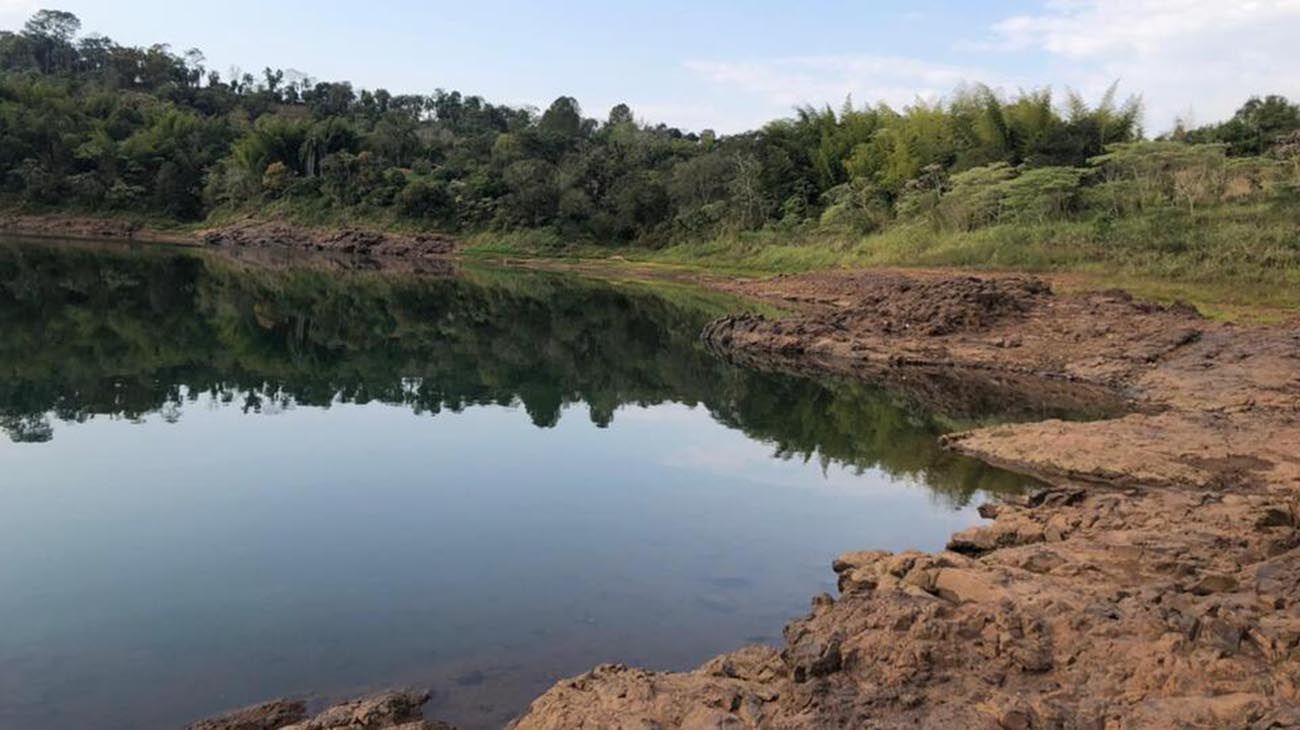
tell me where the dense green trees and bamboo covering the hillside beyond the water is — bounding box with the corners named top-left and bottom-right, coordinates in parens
top-left (0, 10), bottom-right (1300, 245)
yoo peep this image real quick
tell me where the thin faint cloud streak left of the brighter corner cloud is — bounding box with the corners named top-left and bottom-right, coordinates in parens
top-left (685, 55), bottom-right (997, 109)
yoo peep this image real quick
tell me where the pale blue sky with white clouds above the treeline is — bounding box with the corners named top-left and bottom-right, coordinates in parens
top-left (0, 0), bottom-right (1300, 134)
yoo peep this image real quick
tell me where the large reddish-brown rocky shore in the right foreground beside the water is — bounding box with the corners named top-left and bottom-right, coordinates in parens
top-left (512, 273), bottom-right (1300, 730)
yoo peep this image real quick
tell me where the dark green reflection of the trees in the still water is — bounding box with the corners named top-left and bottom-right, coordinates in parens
top-left (0, 245), bottom-right (1018, 499)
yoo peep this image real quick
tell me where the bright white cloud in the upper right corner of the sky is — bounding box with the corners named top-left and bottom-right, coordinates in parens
top-left (988, 0), bottom-right (1300, 131)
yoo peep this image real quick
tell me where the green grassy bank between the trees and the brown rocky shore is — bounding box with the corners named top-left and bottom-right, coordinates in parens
top-left (467, 204), bottom-right (1300, 320)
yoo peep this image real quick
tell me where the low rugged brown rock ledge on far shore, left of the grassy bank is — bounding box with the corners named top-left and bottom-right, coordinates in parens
top-left (200, 221), bottom-right (456, 258)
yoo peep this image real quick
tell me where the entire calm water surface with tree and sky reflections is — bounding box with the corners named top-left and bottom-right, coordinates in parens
top-left (0, 242), bottom-right (1019, 730)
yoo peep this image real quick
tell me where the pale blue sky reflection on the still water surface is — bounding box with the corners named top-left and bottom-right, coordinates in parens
top-left (0, 397), bottom-right (976, 727)
